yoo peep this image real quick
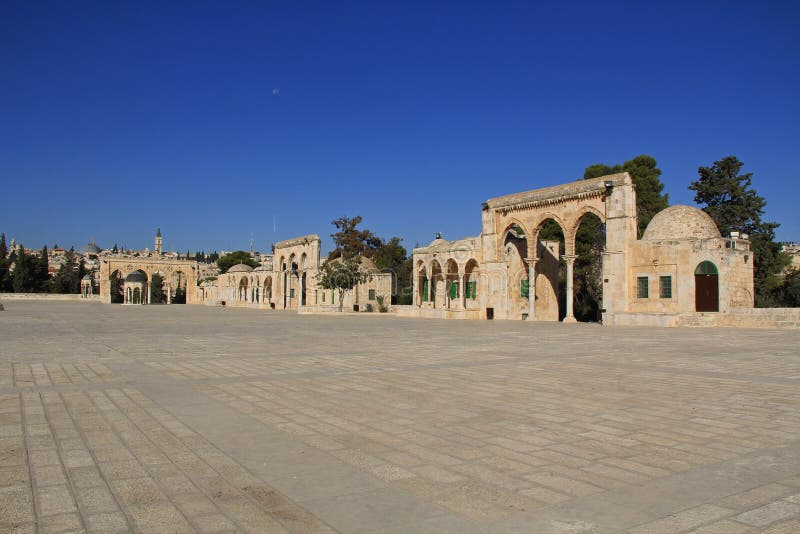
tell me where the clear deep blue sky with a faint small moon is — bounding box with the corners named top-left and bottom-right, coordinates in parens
top-left (0, 1), bottom-right (800, 255)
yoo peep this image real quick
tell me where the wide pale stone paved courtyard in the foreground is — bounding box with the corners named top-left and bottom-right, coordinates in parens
top-left (0, 301), bottom-right (800, 533)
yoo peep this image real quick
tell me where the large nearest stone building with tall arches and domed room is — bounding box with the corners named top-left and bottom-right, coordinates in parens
top-left (400, 173), bottom-right (753, 325)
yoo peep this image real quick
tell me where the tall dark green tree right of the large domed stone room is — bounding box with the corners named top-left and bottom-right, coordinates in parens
top-left (689, 156), bottom-right (790, 308)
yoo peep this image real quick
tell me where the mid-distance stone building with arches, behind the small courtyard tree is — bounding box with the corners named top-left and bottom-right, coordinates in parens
top-left (198, 234), bottom-right (392, 311)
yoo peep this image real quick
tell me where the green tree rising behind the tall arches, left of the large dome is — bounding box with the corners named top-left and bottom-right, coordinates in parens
top-left (583, 154), bottom-right (669, 237)
